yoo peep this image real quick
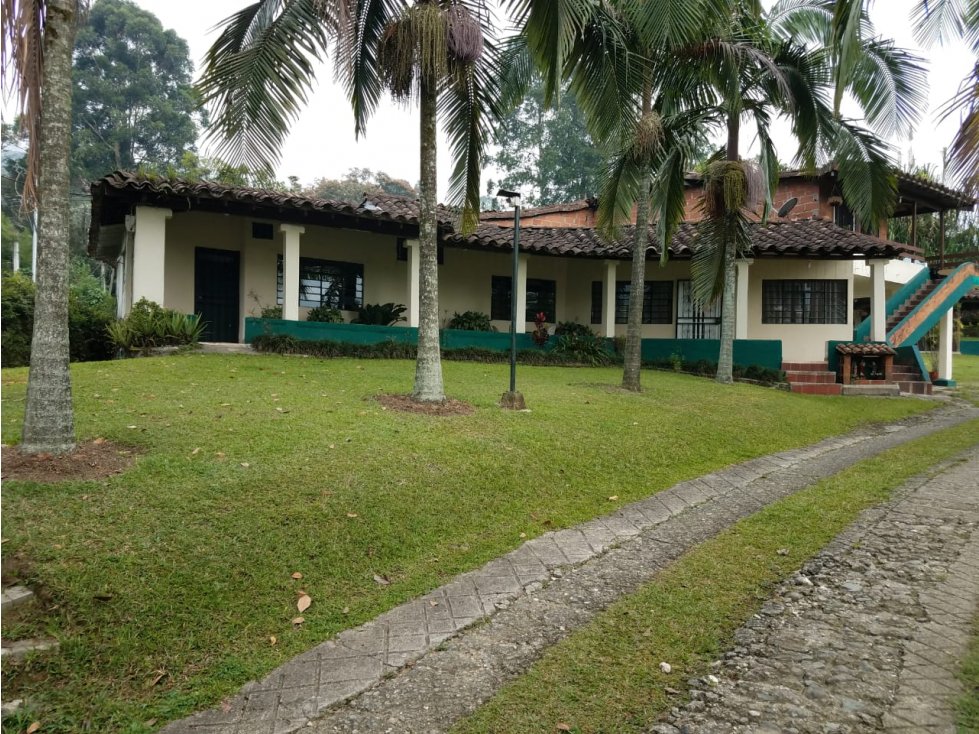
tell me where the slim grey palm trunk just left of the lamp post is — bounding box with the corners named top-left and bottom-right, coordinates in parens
top-left (412, 74), bottom-right (445, 403)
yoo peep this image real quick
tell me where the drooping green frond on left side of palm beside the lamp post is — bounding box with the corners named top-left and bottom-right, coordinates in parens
top-left (197, 0), bottom-right (333, 170)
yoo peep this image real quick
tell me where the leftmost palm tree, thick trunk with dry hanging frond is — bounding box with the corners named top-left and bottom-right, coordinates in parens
top-left (2, 0), bottom-right (78, 453)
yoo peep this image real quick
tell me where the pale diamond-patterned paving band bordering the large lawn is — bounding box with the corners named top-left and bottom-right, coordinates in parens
top-left (162, 406), bottom-right (979, 734)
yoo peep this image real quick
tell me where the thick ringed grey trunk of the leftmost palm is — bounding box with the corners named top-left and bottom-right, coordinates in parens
top-left (21, 0), bottom-right (77, 454)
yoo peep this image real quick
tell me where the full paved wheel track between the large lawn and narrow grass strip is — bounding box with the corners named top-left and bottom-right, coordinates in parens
top-left (163, 405), bottom-right (979, 734)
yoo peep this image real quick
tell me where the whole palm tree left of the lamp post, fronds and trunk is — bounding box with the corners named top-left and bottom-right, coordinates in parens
top-left (199, 0), bottom-right (497, 402)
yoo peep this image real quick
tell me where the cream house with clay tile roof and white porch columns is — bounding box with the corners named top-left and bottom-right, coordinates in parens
top-left (90, 172), bottom-right (971, 394)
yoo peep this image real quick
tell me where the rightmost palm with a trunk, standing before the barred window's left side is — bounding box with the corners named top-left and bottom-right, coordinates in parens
top-left (691, 0), bottom-right (925, 383)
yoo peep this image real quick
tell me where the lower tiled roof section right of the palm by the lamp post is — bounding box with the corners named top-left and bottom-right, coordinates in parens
top-left (445, 220), bottom-right (910, 259)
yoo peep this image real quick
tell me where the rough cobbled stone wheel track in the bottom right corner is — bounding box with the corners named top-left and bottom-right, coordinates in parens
top-left (651, 449), bottom-right (979, 734)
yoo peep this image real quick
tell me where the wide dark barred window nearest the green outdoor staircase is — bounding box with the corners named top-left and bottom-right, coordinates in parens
top-left (761, 280), bottom-right (849, 324)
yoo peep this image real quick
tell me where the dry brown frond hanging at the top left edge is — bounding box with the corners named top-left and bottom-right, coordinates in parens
top-left (0, 0), bottom-right (45, 210)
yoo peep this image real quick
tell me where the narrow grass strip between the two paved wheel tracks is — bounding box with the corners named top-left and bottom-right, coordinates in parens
top-left (453, 421), bottom-right (979, 734)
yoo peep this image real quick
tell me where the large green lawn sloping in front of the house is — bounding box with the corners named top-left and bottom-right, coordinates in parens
top-left (2, 355), bottom-right (931, 731)
